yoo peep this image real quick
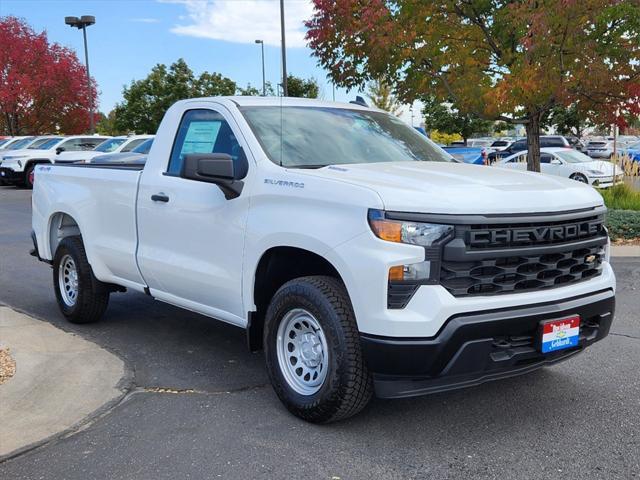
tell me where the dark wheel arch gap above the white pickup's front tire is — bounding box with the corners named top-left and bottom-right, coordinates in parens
top-left (247, 246), bottom-right (344, 351)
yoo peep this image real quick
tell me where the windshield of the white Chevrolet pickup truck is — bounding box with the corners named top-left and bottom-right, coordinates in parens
top-left (241, 107), bottom-right (455, 168)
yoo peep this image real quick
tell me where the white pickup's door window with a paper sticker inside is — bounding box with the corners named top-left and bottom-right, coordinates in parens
top-left (167, 109), bottom-right (240, 175)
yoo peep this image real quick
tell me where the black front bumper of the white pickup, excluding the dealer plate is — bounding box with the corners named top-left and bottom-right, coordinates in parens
top-left (361, 290), bottom-right (615, 398)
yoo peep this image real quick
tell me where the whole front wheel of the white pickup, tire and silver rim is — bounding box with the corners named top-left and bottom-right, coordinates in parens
top-left (264, 276), bottom-right (373, 423)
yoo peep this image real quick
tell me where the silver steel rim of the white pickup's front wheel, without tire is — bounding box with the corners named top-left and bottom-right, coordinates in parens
top-left (276, 308), bottom-right (329, 395)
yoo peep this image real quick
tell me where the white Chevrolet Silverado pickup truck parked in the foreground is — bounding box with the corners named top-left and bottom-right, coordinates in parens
top-left (32, 97), bottom-right (615, 422)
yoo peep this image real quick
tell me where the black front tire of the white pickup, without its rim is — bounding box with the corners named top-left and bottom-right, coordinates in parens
top-left (263, 276), bottom-right (373, 423)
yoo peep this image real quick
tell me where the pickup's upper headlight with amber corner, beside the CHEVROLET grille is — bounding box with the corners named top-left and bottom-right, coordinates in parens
top-left (369, 210), bottom-right (453, 247)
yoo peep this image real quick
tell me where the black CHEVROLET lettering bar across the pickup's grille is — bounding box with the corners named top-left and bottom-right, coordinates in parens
top-left (468, 220), bottom-right (603, 247)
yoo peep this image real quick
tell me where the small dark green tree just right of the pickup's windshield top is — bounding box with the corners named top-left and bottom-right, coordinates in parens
top-left (422, 97), bottom-right (493, 145)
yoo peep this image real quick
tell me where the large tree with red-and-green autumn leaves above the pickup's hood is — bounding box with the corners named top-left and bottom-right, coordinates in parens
top-left (306, 0), bottom-right (640, 171)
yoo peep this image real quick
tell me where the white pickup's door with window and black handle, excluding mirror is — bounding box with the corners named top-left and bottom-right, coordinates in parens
top-left (137, 107), bottom-right (251, 325)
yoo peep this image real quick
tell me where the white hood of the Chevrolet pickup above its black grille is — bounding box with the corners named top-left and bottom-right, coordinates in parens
top-left (296, 162), bottom-right (603, 214)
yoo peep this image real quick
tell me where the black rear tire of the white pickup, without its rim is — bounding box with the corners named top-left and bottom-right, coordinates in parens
top-left (53, 236), bottom-right (109, 323)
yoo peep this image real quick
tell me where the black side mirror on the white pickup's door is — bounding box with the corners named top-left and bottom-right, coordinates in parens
top-left (180, 149), bottom-right (249, 200)
